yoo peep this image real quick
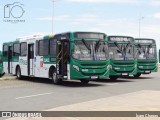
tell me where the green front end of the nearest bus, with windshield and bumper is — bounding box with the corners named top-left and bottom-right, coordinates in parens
top-left (57, 32), bottom-right (109, 83)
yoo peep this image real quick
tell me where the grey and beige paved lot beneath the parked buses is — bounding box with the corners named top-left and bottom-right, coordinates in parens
top-left (0, 72), bottom-right (160, 119)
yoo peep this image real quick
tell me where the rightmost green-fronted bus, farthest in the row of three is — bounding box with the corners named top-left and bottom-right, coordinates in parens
top-left (135, 38), bottom-right (158, 77)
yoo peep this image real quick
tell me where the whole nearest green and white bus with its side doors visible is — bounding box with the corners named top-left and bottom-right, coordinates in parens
top-left (3, 32), bottom-right (110, 84)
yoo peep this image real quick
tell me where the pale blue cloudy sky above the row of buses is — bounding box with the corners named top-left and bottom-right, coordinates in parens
top-left (0, 0), bottom-right (160, 49)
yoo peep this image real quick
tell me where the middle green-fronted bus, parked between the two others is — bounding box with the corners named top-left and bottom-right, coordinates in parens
top-left (108, 36), bottom-right (137, 80)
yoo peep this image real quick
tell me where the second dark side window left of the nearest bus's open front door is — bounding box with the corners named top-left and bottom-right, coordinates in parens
top-left (39, 40), bottom-right (49, 56)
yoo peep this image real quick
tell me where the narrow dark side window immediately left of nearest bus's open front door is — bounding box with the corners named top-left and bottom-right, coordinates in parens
top-left (50, 39), bottom-right (57, 56)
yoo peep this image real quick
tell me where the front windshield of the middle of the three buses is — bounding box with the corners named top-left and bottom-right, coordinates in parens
top-left (109, 42), bottom-right (134, 60)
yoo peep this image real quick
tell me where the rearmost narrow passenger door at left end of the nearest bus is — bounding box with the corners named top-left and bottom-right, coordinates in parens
top-left (8, 46), bottom-right (13, 74)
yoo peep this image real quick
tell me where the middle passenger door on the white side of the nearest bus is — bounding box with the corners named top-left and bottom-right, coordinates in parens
top-left (27, 44), bottom-right (34, 76)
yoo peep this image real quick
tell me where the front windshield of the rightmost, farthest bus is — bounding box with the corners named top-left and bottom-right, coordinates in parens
top-left (136, 44), bottom-right (157, 59)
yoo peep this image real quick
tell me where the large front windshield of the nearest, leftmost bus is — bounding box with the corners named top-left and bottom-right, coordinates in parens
top-left (73, 39), bottom-right (107, 60)
